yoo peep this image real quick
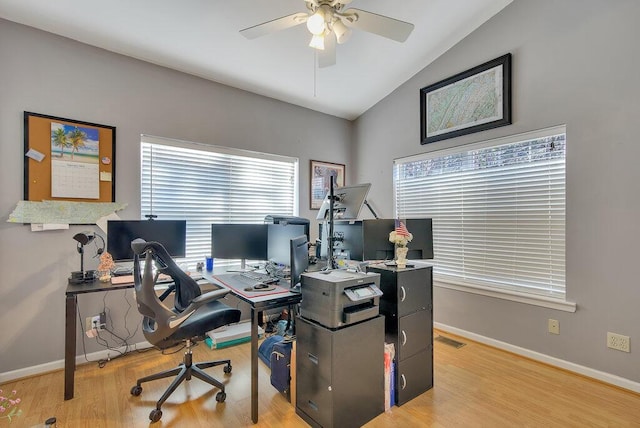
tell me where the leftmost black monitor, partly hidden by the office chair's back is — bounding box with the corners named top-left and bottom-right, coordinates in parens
top-left (107, 220), bottom-right (187, 262)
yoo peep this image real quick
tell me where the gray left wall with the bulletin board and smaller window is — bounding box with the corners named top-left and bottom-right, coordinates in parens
top-left (0, 20), bottom-right (352, 374)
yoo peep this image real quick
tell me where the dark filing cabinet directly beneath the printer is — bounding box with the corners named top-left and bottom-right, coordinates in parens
top-left (296, 316), bottom-right (384, 428)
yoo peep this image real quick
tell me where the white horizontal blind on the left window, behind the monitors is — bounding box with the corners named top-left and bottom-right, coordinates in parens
top-left (140, 135), bottom-right (298, 264)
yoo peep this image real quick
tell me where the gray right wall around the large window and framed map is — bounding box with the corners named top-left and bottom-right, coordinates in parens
top-left (353, 0), bottom-right (640, 382)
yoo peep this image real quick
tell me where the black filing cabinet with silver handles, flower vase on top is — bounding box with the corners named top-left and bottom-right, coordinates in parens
top-left (367, 265), bottom-right (433, 405)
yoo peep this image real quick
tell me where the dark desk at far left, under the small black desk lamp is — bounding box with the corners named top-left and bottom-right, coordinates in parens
top-left (64, 280), bottom-right (133, 400)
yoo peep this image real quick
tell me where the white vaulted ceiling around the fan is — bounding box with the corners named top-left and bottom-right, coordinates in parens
top-left (0, 0), bottom-right (512, 120)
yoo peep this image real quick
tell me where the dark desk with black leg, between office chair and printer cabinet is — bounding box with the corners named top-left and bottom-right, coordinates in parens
top-left (204, 274), bottom-right (302, 424)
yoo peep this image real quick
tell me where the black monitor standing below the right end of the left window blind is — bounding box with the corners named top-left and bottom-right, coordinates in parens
top-left (211, 223), bottom-right (268, 270)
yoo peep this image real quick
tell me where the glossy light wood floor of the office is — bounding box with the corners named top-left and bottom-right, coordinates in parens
top-left (0, 331), bottom-right (640, 428)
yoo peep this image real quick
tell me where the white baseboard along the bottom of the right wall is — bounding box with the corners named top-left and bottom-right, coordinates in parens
top-left (433, 323), bottom-right (640, 393)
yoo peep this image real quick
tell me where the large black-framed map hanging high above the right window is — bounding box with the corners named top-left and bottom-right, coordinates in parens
top-left (420, 54), bottom-right (511, 144)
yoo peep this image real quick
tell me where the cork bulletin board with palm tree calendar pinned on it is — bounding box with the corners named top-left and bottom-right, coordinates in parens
top-left (24, 111), bottom-right (116, 202)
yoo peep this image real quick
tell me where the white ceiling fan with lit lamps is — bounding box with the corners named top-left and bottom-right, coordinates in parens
top-left (240, 0), bottom-right (413, 67)
